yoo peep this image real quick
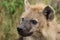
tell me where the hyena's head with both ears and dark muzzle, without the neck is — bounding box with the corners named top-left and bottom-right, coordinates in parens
top-left (17, 0), bottom-right (54, 37)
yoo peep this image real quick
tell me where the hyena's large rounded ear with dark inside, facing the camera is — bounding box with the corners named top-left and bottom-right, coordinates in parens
top-left (43, 6), bottom-right (54, 20)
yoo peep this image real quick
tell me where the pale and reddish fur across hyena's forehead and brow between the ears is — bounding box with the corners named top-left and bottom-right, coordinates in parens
top-left (21, 3), bottom-right (47, 18)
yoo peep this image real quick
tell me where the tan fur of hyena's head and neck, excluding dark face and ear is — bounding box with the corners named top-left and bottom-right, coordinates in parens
top-left (18, 0), bottom-right (56, 40)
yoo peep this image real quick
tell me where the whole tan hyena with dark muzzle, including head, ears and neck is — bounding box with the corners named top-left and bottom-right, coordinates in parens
top-left (17, 0), bottom-right (56, 40)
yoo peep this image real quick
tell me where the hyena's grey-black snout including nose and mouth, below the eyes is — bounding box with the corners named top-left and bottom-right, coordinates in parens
top-left (17, 22), bottom-right (32, 36)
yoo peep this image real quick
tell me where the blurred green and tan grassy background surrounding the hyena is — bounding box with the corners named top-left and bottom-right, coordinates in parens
top-left (0, 0), bottom-right (60, 40)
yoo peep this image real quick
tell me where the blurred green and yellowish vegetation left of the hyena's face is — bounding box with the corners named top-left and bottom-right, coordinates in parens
top-left (0, 0), bottom-right (24, 40)
